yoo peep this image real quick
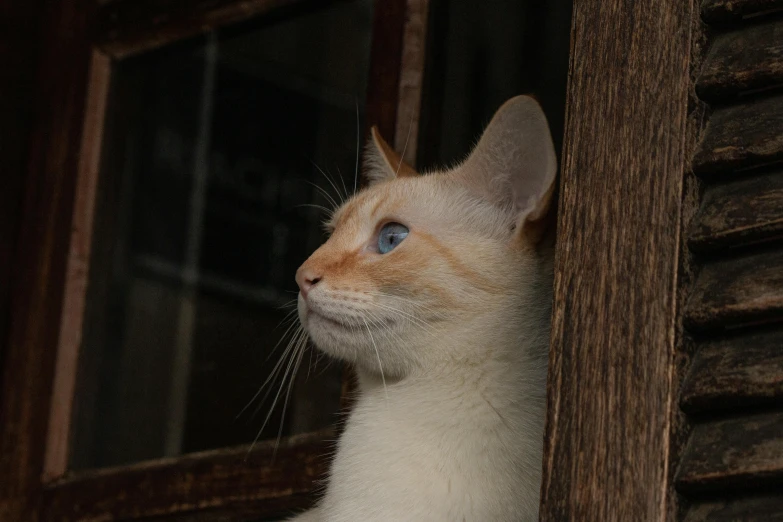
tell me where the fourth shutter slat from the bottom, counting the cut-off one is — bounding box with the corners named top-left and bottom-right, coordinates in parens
top-left (684, 247), bottom-right (783, 331)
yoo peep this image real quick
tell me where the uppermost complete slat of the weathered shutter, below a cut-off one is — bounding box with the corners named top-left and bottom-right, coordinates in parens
top-left (696, 20), bottom-right (783, 102)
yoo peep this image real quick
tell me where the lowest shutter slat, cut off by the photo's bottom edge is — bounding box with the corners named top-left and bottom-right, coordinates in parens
top-left (685, 495), bottom-right (783, 522)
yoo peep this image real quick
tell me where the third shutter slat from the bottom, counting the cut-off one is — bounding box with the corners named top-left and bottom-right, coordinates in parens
top-left (680, 329), bottom-right (783, 413)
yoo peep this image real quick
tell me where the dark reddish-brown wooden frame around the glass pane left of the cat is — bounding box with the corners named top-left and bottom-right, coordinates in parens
top-left (0, 0), bottom-right (427, 521)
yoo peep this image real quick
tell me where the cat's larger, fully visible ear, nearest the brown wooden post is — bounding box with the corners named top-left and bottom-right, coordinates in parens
top-left (458, 96), bottom-right (557, 236)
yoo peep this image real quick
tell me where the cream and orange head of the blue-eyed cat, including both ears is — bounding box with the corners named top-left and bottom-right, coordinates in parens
top-left (296, 96), bottom-right (557, 379)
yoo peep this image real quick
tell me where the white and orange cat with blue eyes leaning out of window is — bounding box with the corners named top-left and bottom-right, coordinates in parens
top-left (292, 96), bottom-right (557, 522)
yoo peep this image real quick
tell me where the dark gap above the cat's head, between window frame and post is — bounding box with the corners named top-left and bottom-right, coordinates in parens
top-left (417, 0), bottom-right (573, 170)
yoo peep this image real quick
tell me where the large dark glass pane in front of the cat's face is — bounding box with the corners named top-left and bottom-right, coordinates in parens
top-left (71, 0), bottom-right (372, 469)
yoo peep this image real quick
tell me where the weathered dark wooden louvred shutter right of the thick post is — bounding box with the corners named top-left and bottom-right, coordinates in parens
top-left (676, 0), bottom-right (783, 522)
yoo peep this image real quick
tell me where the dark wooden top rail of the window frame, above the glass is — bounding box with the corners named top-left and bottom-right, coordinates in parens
top-left (97, 0), bottom-right (316, 58)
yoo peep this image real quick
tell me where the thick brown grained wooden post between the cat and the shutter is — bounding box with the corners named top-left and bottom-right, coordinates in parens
top-left (540, 0), bottom-right (693, 522)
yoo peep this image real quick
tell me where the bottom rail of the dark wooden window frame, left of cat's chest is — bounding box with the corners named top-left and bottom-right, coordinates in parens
top-left (42, 430), bottom-right (334, 522)
